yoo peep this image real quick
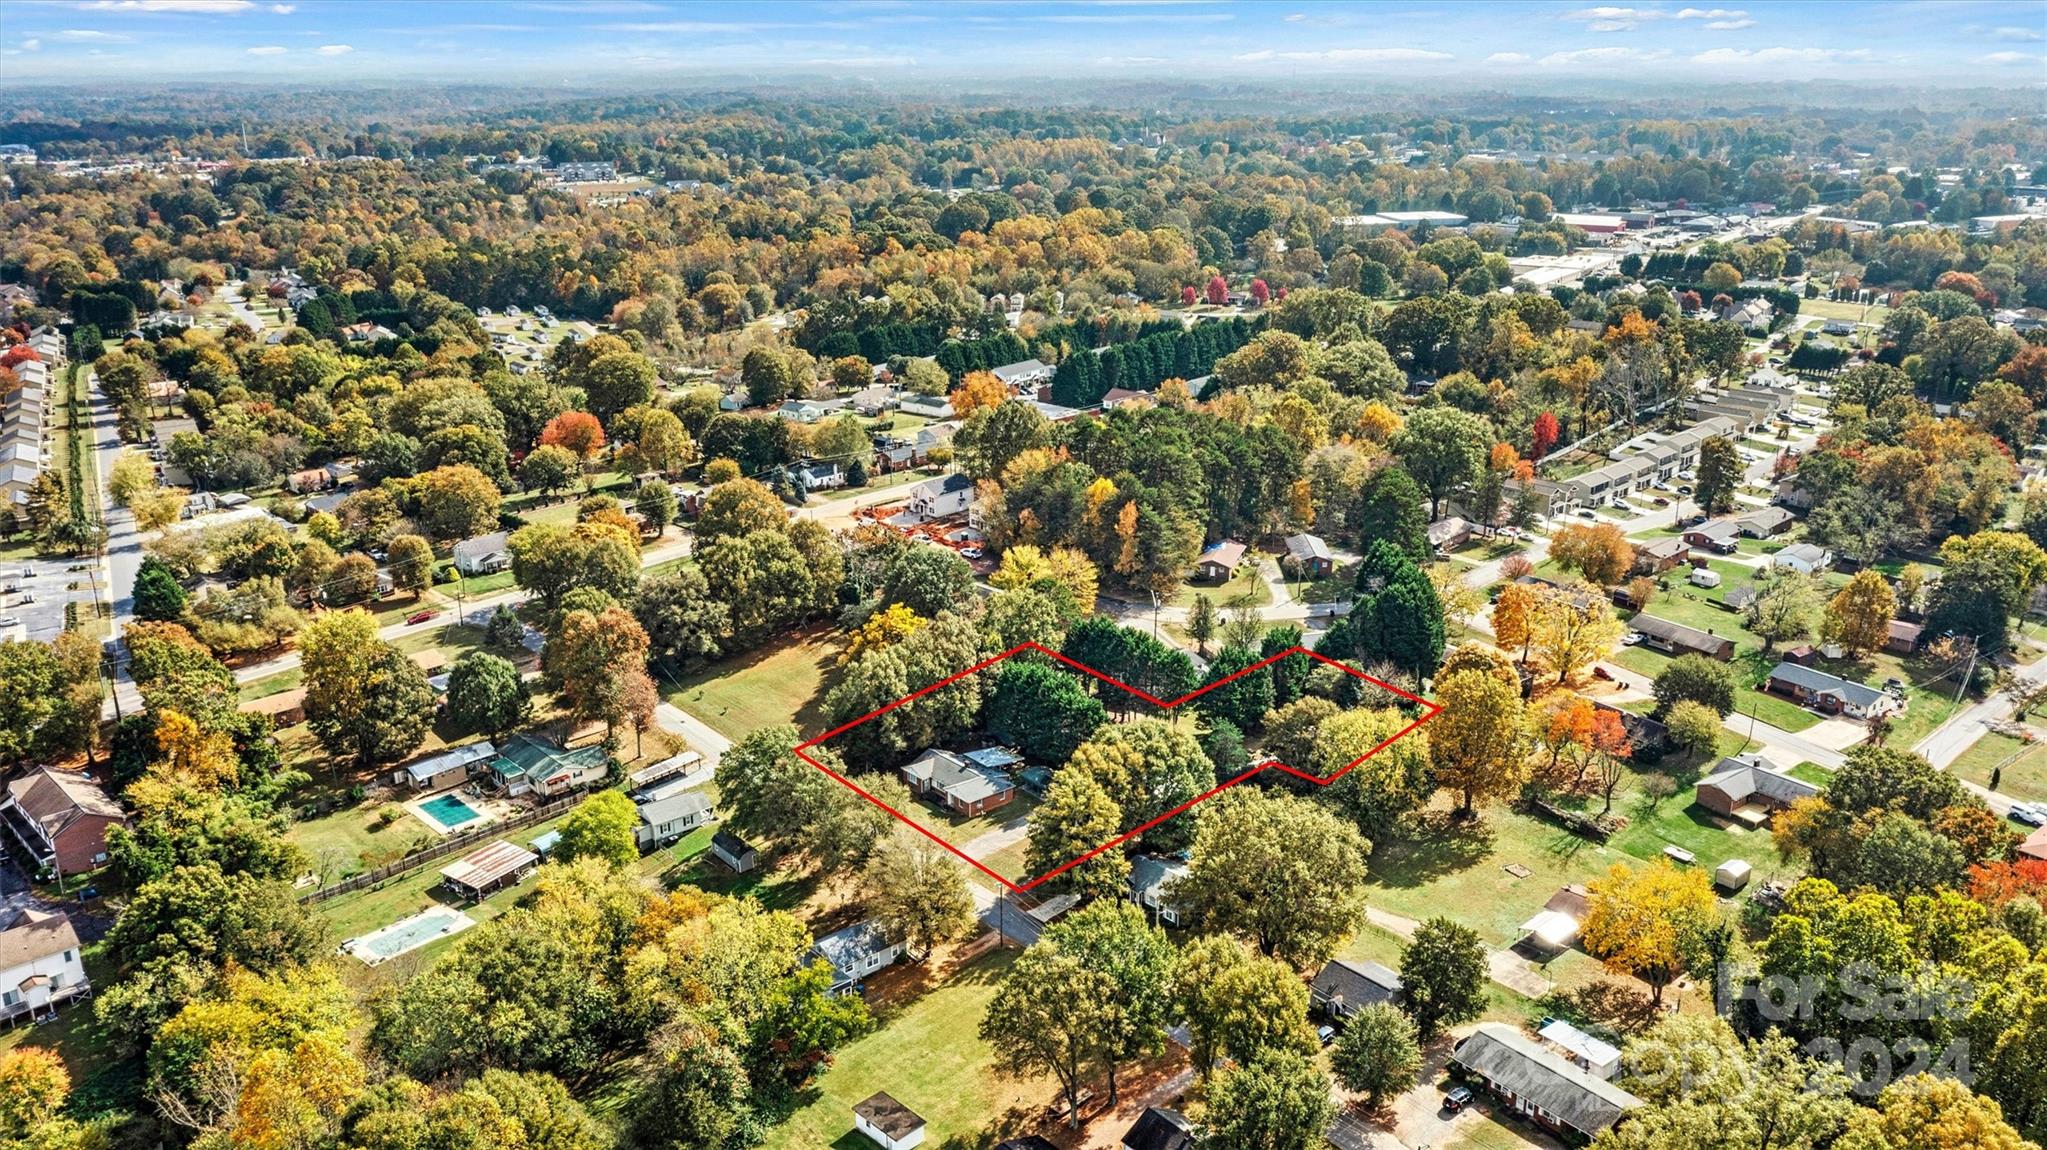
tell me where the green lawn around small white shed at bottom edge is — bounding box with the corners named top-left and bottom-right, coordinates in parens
top-left (761, 949), bottom-right (1054, 1150)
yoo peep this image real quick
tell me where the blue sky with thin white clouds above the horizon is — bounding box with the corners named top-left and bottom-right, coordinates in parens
top-left (0, 0), bottom-right (2047, 92)
